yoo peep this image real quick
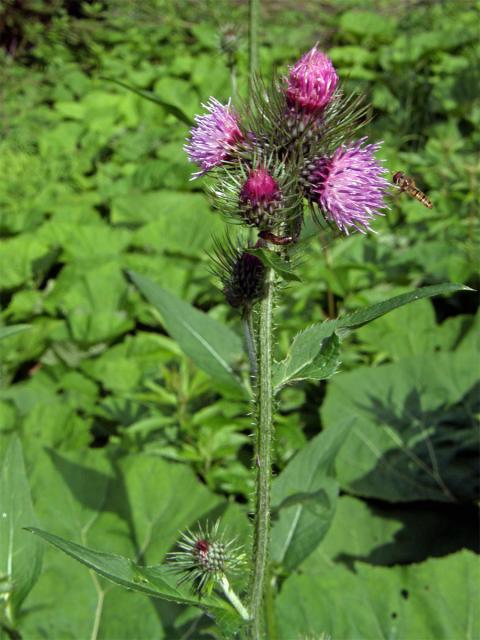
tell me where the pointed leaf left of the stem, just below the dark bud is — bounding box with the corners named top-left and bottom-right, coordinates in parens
top-left (129, 272), bottom-right (243, 389)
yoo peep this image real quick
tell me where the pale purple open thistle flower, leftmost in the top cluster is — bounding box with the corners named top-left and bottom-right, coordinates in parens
top-left (184, 98), bottom-right (243, 178)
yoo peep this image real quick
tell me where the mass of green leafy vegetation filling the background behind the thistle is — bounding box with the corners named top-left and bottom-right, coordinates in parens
top-left (0, 0), bottom-right (480, 640)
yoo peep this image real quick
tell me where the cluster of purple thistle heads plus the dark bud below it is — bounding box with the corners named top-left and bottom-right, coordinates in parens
top-left (185, 46), bottom-right (389, 307)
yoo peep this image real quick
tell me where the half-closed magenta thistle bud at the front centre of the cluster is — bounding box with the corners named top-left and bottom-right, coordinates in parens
top-left (239, 167), bottom-right (281, 227)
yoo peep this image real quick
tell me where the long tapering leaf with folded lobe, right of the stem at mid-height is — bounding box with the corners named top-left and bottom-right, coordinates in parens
top-left (273, 283), bottom-right (471, 391)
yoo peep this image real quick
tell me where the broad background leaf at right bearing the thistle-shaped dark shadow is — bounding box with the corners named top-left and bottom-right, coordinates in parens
top-left (321, 349), bottom-right (480, 502)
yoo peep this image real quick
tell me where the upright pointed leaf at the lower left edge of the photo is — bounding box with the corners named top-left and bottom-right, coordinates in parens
top-left (0, 436), bottom-right (43, 617)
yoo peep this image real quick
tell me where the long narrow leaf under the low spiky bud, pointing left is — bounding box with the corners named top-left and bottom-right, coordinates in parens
top-left (27, 527), bottom-right (238, 632)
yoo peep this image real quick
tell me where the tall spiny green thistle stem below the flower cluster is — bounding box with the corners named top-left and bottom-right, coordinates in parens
top-left (249, 269), bottom-right (274, 640)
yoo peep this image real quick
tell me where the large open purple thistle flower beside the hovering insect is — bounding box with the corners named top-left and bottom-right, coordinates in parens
top-left (306, 138), bottom-right (390, 235)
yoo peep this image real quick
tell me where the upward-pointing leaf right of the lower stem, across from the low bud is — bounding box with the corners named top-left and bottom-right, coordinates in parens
top-left (271, 419), bottom-right (353, 569)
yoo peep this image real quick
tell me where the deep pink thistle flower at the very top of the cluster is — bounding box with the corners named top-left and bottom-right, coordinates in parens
top-left (287, 46), bottom-right (338, 113)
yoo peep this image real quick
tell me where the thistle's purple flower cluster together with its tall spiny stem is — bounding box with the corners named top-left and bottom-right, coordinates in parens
top-left (181, 46), bottom-right (389, 638)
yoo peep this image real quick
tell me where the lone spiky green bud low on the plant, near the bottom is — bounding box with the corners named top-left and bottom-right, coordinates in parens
top-left (167, 521), bottom-right (244, 595)
